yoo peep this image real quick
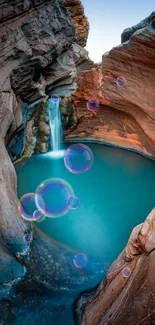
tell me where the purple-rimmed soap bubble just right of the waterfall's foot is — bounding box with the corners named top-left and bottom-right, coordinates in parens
top-left (64, 144), bottom-right (94, 174)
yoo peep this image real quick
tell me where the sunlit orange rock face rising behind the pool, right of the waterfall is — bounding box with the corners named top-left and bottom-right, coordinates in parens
top-left (68, 13), bottom-right (155, 157)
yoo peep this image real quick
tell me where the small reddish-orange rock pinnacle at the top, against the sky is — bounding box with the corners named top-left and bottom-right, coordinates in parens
top-left (64, 0), bottom-right (89, 47)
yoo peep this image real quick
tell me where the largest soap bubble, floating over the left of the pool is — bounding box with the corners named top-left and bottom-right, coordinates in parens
top-left (36, 178), bottom-right (74, 218)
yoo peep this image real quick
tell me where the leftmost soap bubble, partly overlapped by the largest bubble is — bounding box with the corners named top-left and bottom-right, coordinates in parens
top-left (18, 193), bottom-right (45, 221)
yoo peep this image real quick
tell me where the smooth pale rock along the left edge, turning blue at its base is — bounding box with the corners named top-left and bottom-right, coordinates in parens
top-left (0, 90), bottom-right (32, 299)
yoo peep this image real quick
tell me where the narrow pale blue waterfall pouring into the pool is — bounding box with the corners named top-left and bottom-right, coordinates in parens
top-left (48, 96), bottom-right (62, 151)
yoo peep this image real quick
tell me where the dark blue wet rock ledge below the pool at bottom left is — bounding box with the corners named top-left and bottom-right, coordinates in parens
top-left (0, 229), bottom-right (103, 325)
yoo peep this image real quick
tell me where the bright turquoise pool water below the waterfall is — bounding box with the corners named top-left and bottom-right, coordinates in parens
top-left (17, 144), bottom-right (155, 264)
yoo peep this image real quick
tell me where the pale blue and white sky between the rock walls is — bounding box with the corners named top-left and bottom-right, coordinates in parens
top-left (82, 0), bottom-right (155, 62)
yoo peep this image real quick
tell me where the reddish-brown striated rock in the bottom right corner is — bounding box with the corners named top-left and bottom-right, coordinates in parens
top-left (78, 209), bottom-right (155, 325)
